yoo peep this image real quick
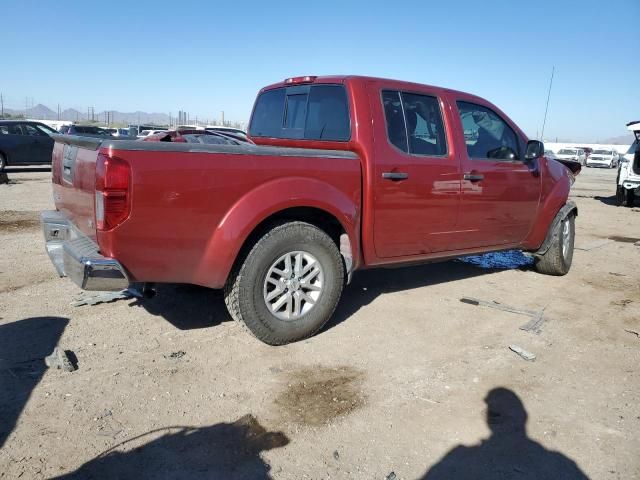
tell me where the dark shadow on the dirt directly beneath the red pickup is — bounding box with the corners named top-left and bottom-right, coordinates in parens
top-left (136, 252), bottom-right (528, 331)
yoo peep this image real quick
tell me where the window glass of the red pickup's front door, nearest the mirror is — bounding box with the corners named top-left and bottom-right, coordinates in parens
top-left (457, 102), bottom-right (520, 160)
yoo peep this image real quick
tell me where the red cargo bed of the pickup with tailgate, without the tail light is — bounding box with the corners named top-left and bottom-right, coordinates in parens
top-left (52, 135), bottom-right (361, 288)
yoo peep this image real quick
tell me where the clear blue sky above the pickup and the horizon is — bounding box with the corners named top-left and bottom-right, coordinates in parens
top-left (0, 0), bottom-right (640, 142)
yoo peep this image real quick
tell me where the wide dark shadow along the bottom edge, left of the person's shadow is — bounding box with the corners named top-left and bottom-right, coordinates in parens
top-left (56, 415), bottom-right (289, 480)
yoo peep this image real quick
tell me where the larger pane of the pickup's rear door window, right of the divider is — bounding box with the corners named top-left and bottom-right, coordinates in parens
top-left (402, 93), bottom-right (447, 155)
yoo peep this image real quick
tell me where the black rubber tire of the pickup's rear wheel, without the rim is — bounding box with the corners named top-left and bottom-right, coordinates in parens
top-left (224, 222), bottom-right (345, 345)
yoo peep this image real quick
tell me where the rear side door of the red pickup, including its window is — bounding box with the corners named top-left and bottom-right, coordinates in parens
top-left (369, 82), bottom-right (460, 258)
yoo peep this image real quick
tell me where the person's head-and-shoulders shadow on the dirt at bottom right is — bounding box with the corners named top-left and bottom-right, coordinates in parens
top-left (422, 388), bottom-right (588, 480)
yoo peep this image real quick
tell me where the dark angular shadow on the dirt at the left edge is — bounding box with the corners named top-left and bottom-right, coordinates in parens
top-left (0, 317), bottom-right (69, 448)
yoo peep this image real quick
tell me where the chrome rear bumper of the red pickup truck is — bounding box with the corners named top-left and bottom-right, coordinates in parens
top-left (40, 210), bottom-right (129, 291)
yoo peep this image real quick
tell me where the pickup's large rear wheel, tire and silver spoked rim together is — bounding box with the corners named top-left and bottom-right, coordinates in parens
top-left (225, 222), bottom-right (345, 345)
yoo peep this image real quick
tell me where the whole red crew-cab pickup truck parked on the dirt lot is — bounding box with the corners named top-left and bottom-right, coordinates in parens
top-left (42, 76), bottom-right (577, 345)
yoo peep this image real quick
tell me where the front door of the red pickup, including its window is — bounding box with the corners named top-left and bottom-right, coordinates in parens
top-left (456, 100), bottom-right (541, 248)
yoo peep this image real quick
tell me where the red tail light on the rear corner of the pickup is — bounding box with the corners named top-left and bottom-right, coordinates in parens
top-left (96, 152), bottom-right (131, 231)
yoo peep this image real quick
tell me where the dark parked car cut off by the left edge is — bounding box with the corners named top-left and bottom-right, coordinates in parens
top-left (0, 120), bottom-right (58, 171)
